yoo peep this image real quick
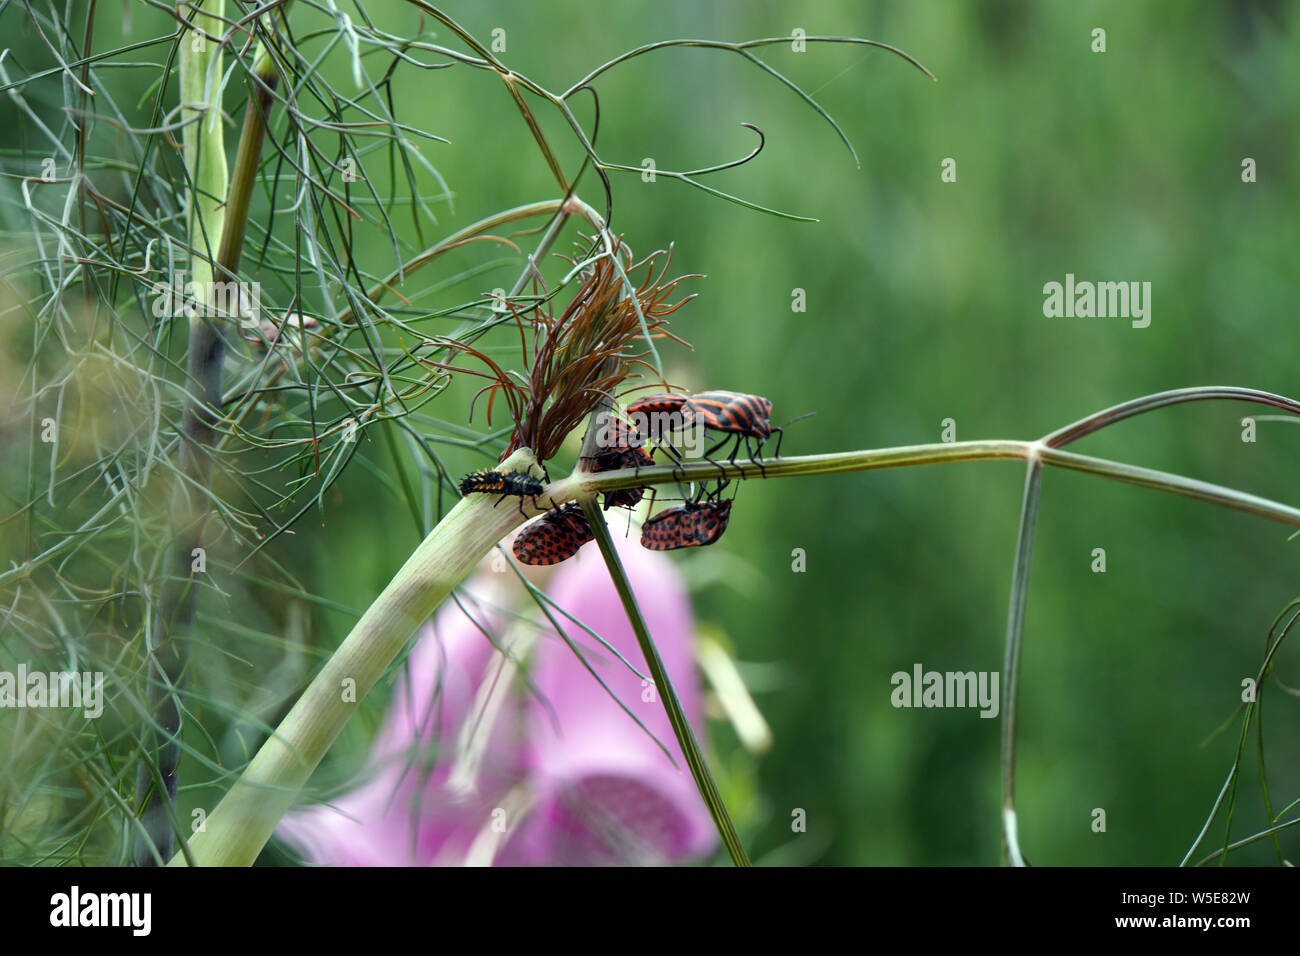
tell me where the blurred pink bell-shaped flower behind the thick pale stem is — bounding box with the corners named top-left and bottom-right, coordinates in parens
top-left (278, 538), bottom-right (716, 866)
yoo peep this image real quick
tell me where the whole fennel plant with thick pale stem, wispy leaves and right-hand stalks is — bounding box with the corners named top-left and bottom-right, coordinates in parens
top-left (0, 0), bottom-right (1300, 865)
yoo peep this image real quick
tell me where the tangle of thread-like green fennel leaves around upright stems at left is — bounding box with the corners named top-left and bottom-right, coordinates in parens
top-left (0, 0), bottom-right (935, 862)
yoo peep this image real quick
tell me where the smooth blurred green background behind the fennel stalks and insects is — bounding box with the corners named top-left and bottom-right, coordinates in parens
top-left (10, 0), bottom-right (1300, 865)
